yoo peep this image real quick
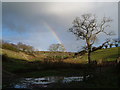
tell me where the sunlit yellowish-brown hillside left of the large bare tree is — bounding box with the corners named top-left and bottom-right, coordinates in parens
top-left (0, 49), bottom-right (74, 61)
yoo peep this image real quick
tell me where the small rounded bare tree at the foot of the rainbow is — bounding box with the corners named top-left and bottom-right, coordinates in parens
top-left (48, 44), bottom-right (66, 52)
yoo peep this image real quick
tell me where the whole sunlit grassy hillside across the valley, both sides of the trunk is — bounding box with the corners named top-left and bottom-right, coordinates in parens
top-left (1, 47), bottom-right (120, 63)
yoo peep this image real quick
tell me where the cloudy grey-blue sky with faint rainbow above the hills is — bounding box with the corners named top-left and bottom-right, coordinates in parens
top-left (2, 2), bottom-right (118, 52)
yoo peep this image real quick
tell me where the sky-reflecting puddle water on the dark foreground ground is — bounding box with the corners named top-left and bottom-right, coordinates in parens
top-left (8, 75), bottom-right (90, 89)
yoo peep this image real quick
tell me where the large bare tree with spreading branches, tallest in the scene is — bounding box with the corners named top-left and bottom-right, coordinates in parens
top-left (69, 14), bottom-right (113, 63)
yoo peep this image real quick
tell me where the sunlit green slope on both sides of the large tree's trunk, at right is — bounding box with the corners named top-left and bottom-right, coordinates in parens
top-left (65, 47), bottom-right (120, 63)
